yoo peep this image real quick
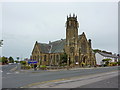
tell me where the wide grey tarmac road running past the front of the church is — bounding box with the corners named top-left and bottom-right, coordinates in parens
top-left (2, 67), bottom-right (118, 88)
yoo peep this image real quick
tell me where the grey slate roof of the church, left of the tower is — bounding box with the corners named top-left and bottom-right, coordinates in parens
top-left (38, 39), bottom-right (65, 53)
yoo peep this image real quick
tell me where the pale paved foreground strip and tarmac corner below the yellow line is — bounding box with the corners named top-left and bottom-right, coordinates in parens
top-left (30, 71), bottom-right (118, 88)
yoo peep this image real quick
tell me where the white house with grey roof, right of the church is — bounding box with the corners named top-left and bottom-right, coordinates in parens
top-left (95, 52), bottom-right (118, 65)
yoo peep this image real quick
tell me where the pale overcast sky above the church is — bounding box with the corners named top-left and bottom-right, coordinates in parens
top-left (0, 2), bottom-right (118, 59)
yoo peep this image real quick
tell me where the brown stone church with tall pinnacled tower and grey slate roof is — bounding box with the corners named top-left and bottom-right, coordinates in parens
top-left (30, 14), bottom-right (96, 67)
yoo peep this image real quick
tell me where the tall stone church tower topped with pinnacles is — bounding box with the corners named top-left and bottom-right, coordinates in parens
top-left (66, 14), bottom-right (79, 65)
